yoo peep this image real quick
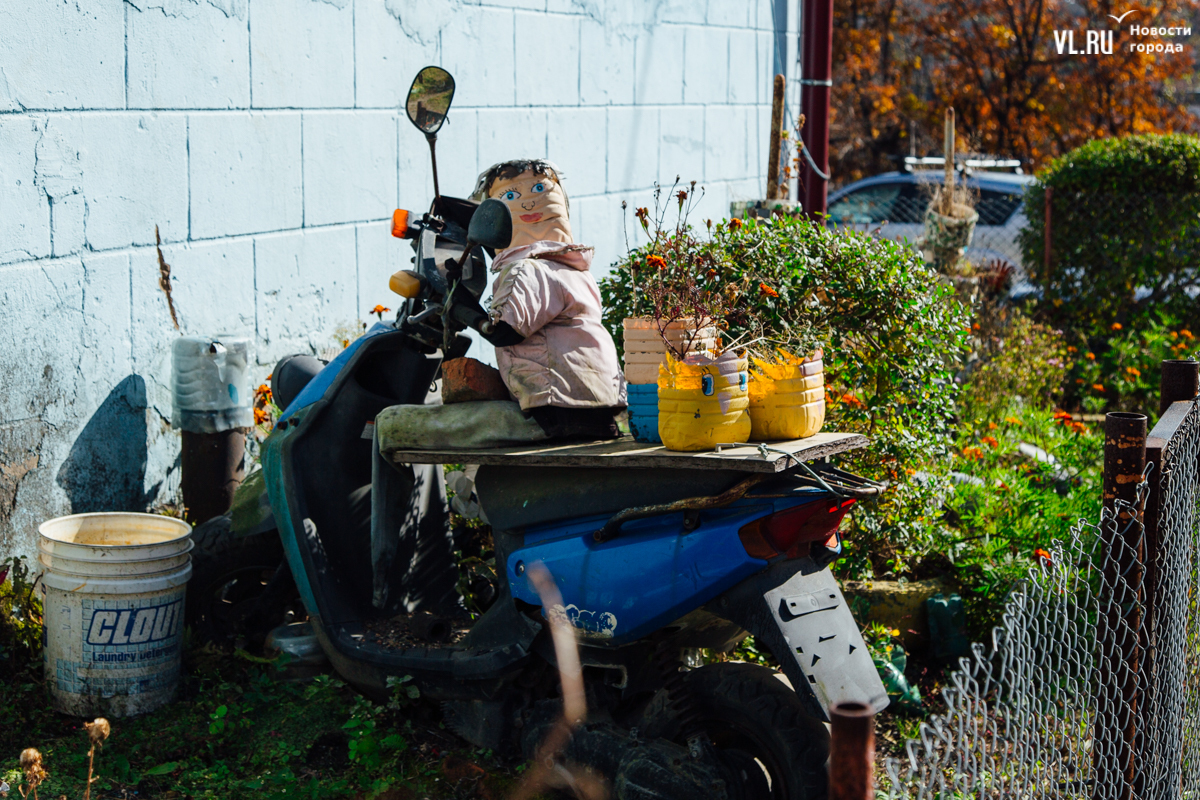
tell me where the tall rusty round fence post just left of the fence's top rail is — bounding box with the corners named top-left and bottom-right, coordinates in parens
top-left (1092, 411), bottom-right (1146, 800)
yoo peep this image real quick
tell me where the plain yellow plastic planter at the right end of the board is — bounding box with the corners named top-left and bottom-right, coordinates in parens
top-left (749, 350), bottom-right (824, 441)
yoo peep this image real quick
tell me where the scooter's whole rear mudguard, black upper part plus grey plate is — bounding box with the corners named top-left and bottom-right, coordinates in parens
top-left (710, 561), bottom-right (888, 718)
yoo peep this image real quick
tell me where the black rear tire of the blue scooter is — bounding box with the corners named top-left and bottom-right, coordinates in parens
top-left (652, 663), bottom-right (829, 800)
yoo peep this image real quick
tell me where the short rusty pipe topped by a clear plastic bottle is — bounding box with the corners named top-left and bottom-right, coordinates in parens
top-left (179, 428), bottom-right (246, 525)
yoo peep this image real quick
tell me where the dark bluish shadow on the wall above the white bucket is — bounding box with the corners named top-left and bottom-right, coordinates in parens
top-left (55, 375), bottom-right (158, 513)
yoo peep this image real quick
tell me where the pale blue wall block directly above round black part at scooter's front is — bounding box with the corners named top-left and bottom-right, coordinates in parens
top-left (254, 225), bottom-right (359, 363)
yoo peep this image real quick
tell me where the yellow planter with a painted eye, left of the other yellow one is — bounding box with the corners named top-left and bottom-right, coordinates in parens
top-left (659, 351), bottom-right (750, 452)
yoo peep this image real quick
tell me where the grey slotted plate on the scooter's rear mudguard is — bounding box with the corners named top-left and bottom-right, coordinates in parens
top-left (763, 570), bottom-right (888, 715)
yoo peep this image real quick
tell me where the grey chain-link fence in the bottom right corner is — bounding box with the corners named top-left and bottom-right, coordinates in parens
top-left (877, 393), bottom-right (1200, 800)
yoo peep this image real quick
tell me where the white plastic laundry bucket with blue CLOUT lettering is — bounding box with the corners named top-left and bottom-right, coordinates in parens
top-left (37, 512), bottom-right (192, 717)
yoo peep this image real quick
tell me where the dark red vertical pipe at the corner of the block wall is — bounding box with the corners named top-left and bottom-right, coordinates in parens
top-left (800, 0), bottom-right (833, 219)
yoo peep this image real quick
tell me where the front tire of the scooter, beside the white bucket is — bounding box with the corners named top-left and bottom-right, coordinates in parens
top-left (184, 516), bottom-right (295, 645)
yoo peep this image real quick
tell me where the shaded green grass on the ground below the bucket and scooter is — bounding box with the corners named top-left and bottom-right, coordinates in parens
top-left (0, 646), bottom-right (520, 800)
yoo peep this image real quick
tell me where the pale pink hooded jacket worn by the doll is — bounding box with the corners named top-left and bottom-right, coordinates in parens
top-left (492, 241), bottom-right (625, 410)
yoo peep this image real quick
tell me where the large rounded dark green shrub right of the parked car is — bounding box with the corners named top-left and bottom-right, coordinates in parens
top-left (1021, 134), bottom-right (1200, 330)
